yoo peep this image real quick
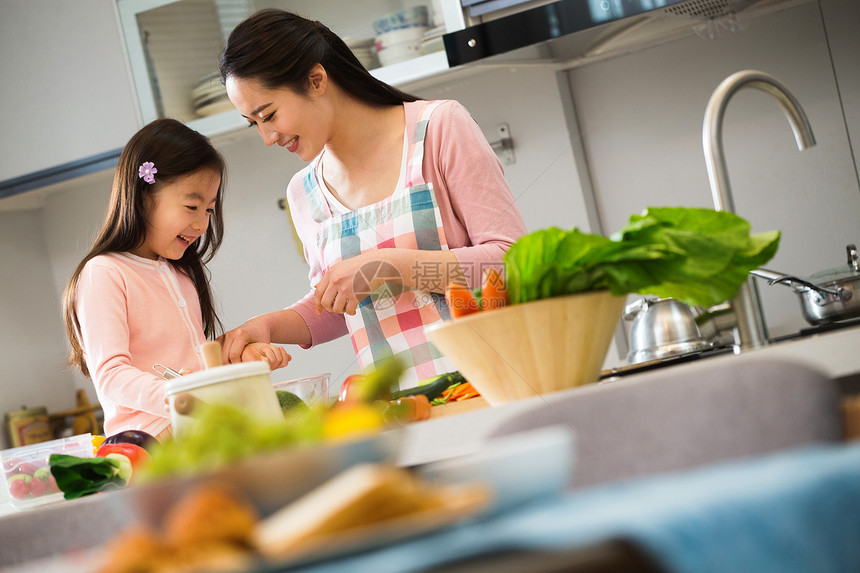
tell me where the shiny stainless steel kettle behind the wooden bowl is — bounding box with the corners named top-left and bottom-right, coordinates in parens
top-left (623, 297), bottom-right (711, 364)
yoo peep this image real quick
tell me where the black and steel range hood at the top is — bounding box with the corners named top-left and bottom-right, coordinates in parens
top-left (444, 0), bottom-right (813, 67)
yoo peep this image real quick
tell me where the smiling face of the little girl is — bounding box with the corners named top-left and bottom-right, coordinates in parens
top-left (133, 169), bottom-right (221, 260)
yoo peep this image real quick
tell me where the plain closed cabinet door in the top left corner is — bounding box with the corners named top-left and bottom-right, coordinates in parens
top-left (0, 0), bottom-right (138, 185)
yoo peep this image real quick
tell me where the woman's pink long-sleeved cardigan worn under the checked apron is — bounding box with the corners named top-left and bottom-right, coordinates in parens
top-left (287, 100), bottom-right (526, 344)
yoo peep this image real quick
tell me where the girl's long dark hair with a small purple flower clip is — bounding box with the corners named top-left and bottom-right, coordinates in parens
top-left (63, 119), bottom-right (227, 376)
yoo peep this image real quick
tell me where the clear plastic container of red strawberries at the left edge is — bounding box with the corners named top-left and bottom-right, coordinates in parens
top-left (0, 434), bottom-right (93, 509)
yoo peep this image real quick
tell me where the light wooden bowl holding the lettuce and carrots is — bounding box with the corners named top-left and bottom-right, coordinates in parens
top-left (425, 291), bottom-right (626, 406)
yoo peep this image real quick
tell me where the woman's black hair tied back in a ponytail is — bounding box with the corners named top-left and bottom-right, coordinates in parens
top-left (220, 8), bottom-right (419, 106)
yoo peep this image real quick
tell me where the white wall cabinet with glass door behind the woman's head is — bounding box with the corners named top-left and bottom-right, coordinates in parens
top-left (117, 0), bottom-right (464, 136)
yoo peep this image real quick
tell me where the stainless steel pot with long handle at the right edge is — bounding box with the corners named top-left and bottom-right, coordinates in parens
top-left (750, 245), bottom-right (860, 326)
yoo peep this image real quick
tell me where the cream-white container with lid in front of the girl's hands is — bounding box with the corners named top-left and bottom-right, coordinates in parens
top-left (167, 361), bottom-right (284, 436)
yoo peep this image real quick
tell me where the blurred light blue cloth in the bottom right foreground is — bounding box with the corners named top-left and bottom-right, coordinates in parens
top-left (273, 445), bottom-right (860, 573)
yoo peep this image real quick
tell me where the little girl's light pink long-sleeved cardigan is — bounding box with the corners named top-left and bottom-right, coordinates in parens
top-left (76, 253), bottom-right (206, 436)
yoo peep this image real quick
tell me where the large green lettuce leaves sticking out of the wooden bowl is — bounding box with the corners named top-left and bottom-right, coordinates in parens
top-left (504, 207), bottom-right (780, 306)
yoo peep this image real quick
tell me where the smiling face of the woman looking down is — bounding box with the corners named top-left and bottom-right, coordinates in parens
top-left (226, 76), bottom-right (328, 161)
